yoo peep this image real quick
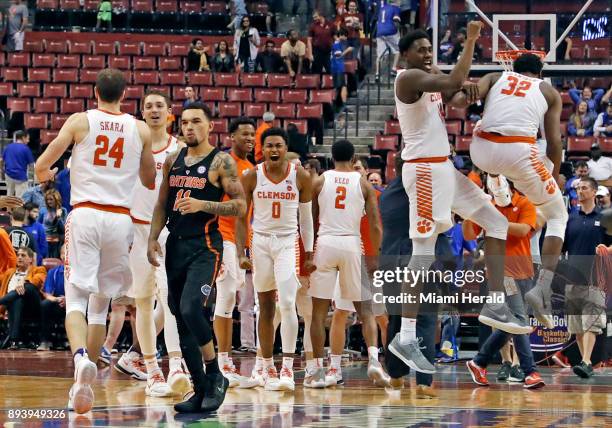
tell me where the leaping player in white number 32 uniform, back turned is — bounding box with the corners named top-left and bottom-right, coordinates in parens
top-left (456, 53), bottom-right (568, 328)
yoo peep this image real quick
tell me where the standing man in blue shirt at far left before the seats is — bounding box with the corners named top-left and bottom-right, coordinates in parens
top-left (2, 131), bottom-right (34, 198)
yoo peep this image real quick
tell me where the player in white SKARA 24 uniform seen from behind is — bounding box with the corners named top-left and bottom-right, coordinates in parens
top-left (36, 69), bottom-right (155, 413)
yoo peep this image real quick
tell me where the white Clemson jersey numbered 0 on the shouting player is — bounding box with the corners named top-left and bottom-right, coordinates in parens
top-left (253, 162), bottom-right (300, 235)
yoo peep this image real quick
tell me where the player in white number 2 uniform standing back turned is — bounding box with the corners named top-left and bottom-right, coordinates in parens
top-left (304, 140), bottom-right (389, 388)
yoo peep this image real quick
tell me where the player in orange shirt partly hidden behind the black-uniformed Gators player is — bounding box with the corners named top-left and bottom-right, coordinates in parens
top-left (214, 117), bottom-right (255, 388)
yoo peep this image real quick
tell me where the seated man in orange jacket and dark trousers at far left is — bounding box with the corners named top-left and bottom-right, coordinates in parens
top-left (0, 247), bottom-right (47, 349)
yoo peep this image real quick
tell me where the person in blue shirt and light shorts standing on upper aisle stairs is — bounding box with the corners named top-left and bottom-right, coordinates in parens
top-left (375, 0), bottom-right (401, 81)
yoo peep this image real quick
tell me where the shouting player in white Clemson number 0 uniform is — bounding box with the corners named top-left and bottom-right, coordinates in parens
top-left (236, 128), bottom-right (314, 391)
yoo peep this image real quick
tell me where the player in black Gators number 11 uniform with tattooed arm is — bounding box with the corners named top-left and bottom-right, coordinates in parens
top-left (147, 103), bottom-right (245, 413)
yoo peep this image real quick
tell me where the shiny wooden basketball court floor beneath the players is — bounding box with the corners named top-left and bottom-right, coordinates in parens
top-left (0, 351), bottom-right (612, 428)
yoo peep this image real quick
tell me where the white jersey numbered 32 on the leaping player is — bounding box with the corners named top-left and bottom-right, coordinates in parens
top-left (480, 71), bottom-right (548, 137)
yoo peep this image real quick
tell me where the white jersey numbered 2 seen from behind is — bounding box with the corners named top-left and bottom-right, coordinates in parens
top-left (317, 170), bottom-right (365, 236)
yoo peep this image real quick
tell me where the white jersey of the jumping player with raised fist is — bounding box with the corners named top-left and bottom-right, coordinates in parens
top-left (394, 70), bottom-right (450, 160)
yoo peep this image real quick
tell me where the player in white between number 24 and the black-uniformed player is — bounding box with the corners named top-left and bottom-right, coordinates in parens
top-left (115, 91), bottom-right (189, 397)
